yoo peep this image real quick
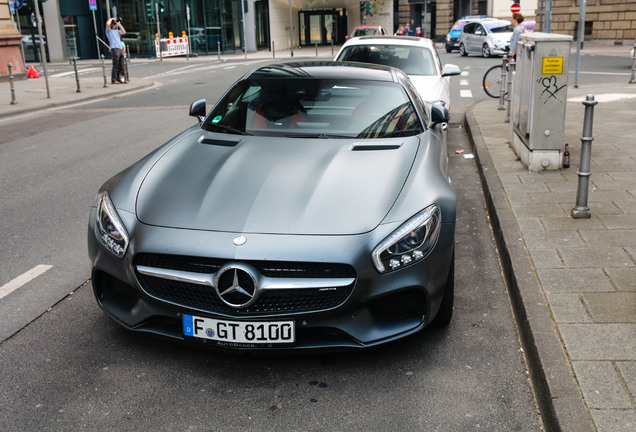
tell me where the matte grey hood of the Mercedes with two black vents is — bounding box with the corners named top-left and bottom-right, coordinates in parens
top-left (136, 131), bottom-right (420, 235)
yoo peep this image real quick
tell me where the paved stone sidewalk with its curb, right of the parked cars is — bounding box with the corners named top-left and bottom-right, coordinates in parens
top-left (466, 82), bottom-right (636, 432)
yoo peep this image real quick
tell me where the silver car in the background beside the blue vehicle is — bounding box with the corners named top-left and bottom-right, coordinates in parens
top-left (459, 20), bottom-right (514, 57)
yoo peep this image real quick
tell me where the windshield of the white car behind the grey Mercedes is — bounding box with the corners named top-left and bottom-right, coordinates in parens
top-left (337, 45), bottom-right (437, 75)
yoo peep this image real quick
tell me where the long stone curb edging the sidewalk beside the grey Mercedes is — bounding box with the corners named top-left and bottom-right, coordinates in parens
top-left (464, 102), bottom-right (596, 432)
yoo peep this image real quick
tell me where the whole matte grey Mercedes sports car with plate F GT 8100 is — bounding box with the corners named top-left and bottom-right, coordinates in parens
top-left (88, 62), bottom-right (456, 350)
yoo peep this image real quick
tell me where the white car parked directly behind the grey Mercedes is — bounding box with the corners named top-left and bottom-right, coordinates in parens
top-left (334, 36), bottom-right (460, 109)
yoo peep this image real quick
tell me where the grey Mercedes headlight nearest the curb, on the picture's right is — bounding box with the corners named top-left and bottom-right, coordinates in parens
top-left (371, 205), bottom-right (442, 273)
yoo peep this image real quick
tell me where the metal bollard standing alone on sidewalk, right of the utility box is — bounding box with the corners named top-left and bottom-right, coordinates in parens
top-left (572, 94), bottom-right (598, 219)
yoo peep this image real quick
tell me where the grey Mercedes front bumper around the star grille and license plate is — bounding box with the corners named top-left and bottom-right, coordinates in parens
top-left (88, 209), bottom-right (455, 350)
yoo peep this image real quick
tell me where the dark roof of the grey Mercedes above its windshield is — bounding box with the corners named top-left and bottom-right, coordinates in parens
top-left (244, 61), bottom-right (408, 82)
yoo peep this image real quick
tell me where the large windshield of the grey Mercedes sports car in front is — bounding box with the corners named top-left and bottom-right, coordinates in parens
top-left (203, 78), bottom-right (423, 139)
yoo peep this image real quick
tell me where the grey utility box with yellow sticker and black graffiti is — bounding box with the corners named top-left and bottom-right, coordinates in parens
top-left (511, 32), bottom-right (572, 171)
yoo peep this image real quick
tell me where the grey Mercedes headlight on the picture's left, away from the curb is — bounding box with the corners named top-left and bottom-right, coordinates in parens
top-left (95, 192), bottom-right (128, 258)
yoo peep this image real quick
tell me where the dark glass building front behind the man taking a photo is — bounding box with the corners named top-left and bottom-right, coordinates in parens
top-left (52, 0), bottom-right (253, 58)
